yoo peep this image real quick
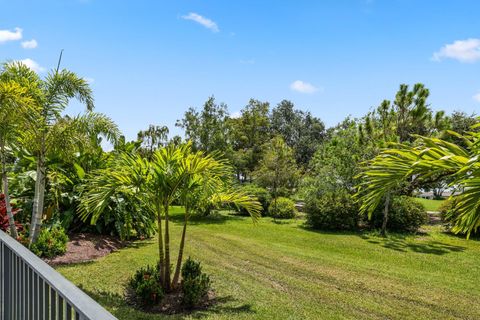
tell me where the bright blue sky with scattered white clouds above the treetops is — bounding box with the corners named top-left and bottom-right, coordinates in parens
top-left (0, 0), bottom-right (480, 139)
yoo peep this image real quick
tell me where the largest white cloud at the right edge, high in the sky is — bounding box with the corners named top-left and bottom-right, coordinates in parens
top-left (432, 38), bottom-right (480, 63)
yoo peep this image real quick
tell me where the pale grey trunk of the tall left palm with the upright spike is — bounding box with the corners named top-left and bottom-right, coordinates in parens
top-left (29, 153), bottom-right (46, 244)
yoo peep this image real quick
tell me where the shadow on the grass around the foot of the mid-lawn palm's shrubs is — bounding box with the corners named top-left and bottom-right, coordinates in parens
top-left (79, 285), bottom-right (255, 320)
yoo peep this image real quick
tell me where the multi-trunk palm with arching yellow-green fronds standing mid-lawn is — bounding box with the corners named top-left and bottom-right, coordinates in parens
top-left (80, 143), bottom-right (261, 292)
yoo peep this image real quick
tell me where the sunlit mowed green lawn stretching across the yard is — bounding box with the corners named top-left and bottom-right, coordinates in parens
top-left (58, 210), bottom-right (480, 320)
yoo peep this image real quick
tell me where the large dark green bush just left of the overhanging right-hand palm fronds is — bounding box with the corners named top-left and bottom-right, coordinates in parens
top-left (304, 190), bottom-right (360, 230)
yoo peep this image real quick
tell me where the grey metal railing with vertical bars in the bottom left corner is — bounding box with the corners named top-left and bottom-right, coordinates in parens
top-left (0, 230), bottom-right (117, 320)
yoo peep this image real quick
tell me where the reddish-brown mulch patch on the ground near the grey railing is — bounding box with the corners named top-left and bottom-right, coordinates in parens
top-left (45, 233), bottom-right (125, 266)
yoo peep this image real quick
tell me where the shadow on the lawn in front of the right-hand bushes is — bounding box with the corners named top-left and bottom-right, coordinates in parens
top-left (360, 234), bottom-right (466, 255)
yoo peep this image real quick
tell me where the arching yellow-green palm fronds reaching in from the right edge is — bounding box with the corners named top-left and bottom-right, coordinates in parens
top-left (356, 123), bottom-right (480, 236)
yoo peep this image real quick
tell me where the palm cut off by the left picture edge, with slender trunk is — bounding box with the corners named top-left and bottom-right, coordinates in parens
top-left (0, 64), bottom-right (33, 238)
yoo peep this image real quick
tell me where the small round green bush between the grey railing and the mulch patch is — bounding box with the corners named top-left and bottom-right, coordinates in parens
top-left (30, 224), bottom-right (68, 258)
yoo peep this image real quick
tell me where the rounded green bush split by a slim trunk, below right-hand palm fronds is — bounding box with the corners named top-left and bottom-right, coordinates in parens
top-left (367, 196), bottom-right (428, 232)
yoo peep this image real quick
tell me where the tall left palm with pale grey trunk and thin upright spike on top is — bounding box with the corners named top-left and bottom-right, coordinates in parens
top-left (2, 56), bottom-right (119, 243)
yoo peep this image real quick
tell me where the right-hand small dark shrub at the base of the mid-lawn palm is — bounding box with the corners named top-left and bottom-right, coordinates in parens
top-left (182, 257), bottom-right (210, 308)
